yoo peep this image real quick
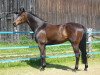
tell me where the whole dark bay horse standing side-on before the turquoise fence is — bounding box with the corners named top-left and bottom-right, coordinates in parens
top-left (13, 8), bottom-right (88, 70)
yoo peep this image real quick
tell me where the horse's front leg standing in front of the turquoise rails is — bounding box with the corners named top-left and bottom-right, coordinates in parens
top-left (39, 44), bottom-right (46, 70)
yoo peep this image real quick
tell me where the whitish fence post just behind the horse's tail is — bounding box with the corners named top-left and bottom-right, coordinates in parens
top-left (87, 28), bottom-right (92, 56)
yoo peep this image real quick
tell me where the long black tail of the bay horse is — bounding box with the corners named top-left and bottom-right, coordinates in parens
top-left (79, 29), bottom-right (87, 64)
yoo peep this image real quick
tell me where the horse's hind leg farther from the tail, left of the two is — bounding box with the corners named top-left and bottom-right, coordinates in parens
top-left (72, 44), bottom-right (80, 70)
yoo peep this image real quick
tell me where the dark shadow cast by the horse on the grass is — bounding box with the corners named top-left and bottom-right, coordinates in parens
top-left (26, 60), bottom-right (75, 71)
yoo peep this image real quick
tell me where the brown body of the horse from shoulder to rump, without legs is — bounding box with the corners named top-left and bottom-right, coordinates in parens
top-left (35, 23), bottom-right (84, 44)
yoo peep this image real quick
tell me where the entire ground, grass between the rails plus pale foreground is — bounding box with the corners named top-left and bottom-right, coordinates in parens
top-left (0, 36), bottom-right (100, 75)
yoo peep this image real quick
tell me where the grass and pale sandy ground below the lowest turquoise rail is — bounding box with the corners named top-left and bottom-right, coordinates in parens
top-left (0, 55), bottom-right (100, 75)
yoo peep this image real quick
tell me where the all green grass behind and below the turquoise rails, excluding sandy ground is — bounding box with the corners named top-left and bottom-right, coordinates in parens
top-left (0, 37), bottom-right (100, 68)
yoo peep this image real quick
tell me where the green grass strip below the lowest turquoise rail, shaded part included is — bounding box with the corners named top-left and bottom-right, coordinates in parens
top-left (0, 55), bottom-right (100, 68)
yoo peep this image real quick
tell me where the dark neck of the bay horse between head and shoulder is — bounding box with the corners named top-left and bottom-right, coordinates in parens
top-left (28, 14), bottom-right (44, 32)
